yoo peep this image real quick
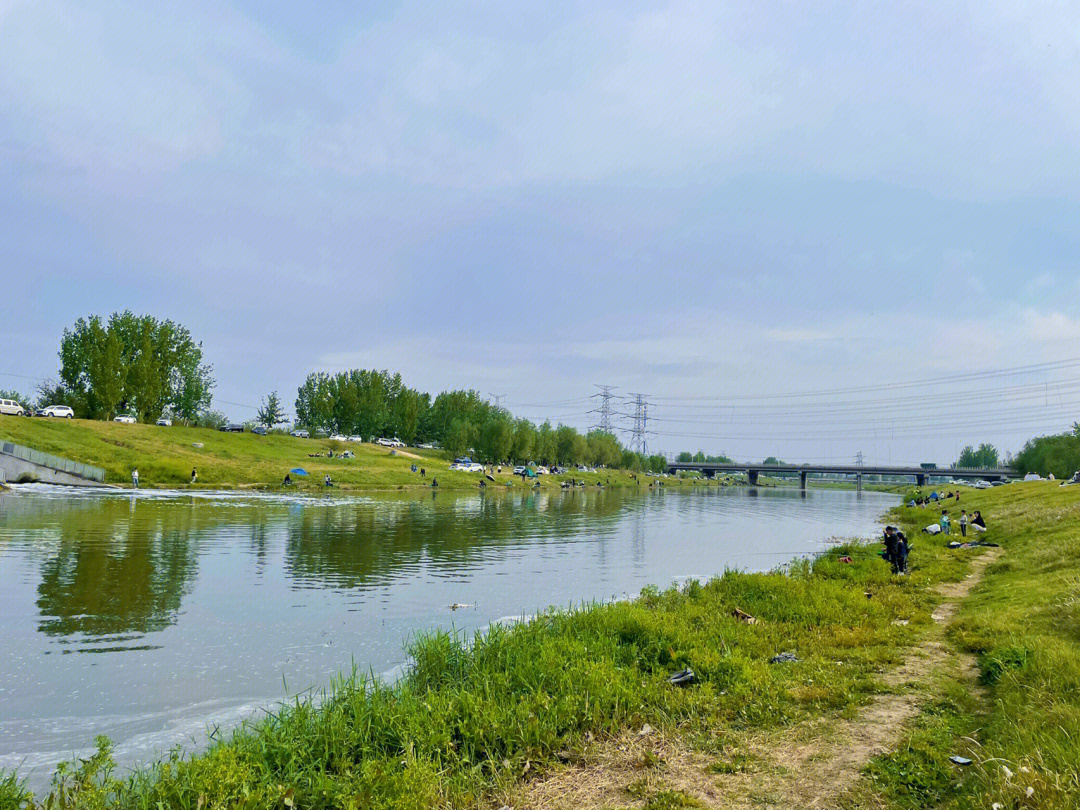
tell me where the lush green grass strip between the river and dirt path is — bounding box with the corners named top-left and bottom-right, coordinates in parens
top-left (0, 488), bottom-right (967, 810)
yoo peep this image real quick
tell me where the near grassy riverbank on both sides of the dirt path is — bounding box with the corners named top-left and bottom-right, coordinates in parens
top-left (0, 484), bottom-right (1080, 808)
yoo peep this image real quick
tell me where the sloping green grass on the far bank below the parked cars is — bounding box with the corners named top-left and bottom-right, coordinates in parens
top-left (0, 417), bottom-right (648, 490)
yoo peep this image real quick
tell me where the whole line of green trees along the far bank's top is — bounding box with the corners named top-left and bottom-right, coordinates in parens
top-left (19, 310), bottom-right (666, 472)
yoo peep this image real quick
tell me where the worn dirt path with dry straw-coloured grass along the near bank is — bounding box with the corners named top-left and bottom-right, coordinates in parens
top-left (496, 549), bottom-right (1000, 810)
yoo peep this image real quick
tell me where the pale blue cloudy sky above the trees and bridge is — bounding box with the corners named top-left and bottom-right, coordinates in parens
top-left (0, 0), bottom-right (1080, 462)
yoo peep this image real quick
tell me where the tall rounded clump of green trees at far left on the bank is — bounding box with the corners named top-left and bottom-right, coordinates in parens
top-left (56, 310), bottom-right (214, 421)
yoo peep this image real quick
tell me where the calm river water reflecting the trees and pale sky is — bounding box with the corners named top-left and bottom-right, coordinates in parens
top-left (0, 485), bottom-right (897, 788)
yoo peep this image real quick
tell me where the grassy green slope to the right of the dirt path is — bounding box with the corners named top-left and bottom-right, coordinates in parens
top-left (846, 482), bottom-right (1080, 810)
